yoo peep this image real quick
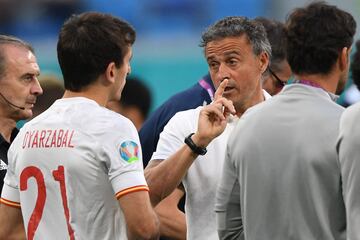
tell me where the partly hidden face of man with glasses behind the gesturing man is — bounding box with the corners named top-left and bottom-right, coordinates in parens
top-left (262, 60), bottom-right (292, 96)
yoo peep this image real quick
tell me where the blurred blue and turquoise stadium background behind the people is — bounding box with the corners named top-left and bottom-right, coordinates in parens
top-left (0, 0), bottom-right (360, 110)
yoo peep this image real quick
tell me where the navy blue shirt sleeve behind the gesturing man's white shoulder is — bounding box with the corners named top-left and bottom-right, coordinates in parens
top-left (139, 75), bottom-right (215, 167)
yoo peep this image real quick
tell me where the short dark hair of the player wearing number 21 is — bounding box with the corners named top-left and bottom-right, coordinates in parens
top-left (57, 12), bottom-right (136, 92)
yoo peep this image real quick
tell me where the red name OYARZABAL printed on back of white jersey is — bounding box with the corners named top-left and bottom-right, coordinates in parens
top-left (22, 129), bottom-right (75, 148)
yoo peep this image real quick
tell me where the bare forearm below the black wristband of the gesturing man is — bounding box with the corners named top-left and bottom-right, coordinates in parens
top-left (145, 145), bottom-right (198, 206)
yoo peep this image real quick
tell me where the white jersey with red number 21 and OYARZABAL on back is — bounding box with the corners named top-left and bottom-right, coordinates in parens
top-left (1, 98), bottom-right (148, 240)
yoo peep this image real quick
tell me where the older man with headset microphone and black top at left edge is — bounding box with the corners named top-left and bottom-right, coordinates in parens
top-left (0, 35), bottom-right (42, 197)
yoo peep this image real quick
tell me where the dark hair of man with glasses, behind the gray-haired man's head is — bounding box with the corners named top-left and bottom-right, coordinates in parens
top-left (254, 17), bottom-right (287, 71)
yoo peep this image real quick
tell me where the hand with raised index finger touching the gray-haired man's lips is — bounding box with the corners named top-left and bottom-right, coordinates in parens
top-left (192, 79), bottom-right (236, 147)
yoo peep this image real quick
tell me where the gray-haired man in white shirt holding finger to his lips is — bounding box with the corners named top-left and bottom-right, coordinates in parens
top-left (145, 17), bottom-right (271, 240)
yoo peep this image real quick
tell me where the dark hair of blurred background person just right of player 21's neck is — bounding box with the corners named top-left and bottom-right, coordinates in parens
top-left (120, 77), bottom-right (152, 119)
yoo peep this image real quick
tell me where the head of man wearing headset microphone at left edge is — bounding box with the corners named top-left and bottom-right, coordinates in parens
top-left (0, 44), bottom-right (42, 121)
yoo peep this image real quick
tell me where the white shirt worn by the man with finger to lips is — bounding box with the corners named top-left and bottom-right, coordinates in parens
top-left (151, 91), bottom-right (270, 240)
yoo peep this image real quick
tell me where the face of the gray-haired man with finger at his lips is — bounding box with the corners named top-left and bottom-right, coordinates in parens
top-left (205, 34), bottom-right (268, 112)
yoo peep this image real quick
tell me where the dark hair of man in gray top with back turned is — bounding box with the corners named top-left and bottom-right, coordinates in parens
top-left (286, 1), bottom-right (356, 74)
